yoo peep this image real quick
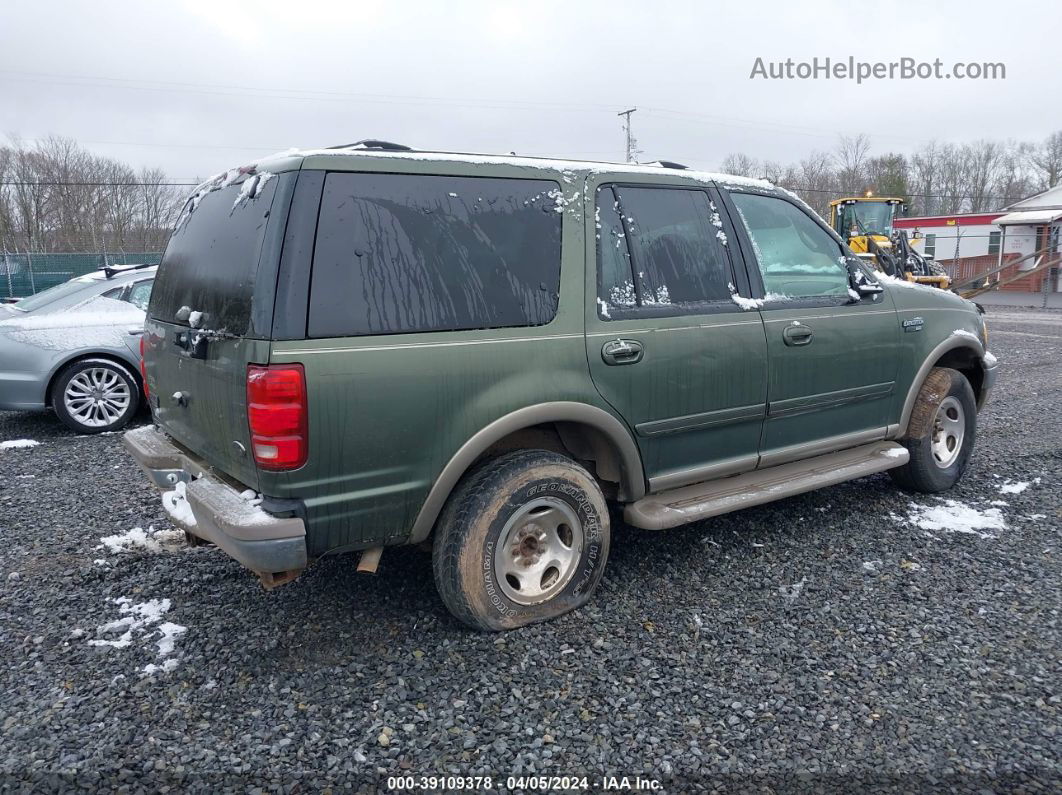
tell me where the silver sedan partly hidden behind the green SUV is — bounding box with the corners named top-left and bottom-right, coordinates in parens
top-left (0, 265), bottom-right (157, 433)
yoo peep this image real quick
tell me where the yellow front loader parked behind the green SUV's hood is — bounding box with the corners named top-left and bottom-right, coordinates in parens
top-left (829, 191), bottom-right (952, 290)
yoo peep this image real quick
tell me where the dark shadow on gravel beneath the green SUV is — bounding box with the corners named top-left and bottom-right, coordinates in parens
top-left (226, 464), bottom-right (906, 649)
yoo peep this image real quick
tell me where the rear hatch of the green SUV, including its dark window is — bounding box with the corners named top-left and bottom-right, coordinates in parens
top-left (144, 171), bottom-right (296, 489)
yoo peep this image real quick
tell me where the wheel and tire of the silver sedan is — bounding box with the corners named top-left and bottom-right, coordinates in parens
top-left (51, 359), bottom-right (140, 434)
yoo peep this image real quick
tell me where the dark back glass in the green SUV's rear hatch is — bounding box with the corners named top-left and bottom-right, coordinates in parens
top-left (149, 175), bottom-right (278, 334)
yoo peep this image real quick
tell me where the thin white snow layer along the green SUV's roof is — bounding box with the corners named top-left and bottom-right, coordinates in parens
top-left (252, 148), bottom-right (775, 190)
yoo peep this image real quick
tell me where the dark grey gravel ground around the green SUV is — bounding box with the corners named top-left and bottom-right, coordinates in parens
top-left (0, 310), bottom-right (1062, 792)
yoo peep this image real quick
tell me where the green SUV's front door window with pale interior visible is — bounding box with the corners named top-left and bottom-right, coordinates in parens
top-left (731, 192), bottom-right (849, 298)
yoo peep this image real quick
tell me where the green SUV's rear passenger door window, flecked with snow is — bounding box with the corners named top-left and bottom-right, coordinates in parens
top-left (597, 186), bottom-right (733, 317)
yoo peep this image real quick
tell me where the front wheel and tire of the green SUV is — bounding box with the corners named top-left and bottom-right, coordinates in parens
top-left (889, 367), bottom-right (977, 494)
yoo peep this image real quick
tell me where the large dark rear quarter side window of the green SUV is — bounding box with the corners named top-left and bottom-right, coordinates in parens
top-left (307, 173), bottom-right (561, 336)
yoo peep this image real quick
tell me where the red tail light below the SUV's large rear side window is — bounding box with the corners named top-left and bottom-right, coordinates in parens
top-left (247, 364), bottom-right (309, 470)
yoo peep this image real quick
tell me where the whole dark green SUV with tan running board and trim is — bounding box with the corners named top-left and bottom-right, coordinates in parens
top-left (124, 141), bottom-right (996, 629)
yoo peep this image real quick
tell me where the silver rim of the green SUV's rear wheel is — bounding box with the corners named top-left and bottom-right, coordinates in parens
top-left (494, 497), bottom-right (583, 605)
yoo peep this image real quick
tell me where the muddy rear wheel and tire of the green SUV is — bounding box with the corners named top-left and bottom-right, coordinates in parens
top-left (432, 450), bottom-right (610, 632)
